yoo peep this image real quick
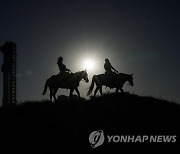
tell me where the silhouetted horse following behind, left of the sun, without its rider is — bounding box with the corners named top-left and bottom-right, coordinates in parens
top-left (42, 70), bottom-right (89, 101)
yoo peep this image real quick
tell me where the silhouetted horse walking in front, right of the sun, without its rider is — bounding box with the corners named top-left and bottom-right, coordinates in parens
top-left (87, 73), bottom-right (134, 96)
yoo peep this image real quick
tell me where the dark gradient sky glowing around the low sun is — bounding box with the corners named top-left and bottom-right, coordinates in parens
top-left (0, 0), bottom-right (180, 103)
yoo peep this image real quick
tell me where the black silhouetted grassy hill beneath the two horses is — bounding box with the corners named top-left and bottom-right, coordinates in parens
top-left (0, 93), bottom-right (180, 154)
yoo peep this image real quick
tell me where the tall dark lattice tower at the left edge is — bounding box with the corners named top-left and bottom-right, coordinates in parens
top-left (0, 41), bottom-right (16, 106)
